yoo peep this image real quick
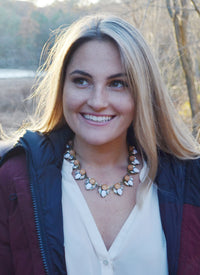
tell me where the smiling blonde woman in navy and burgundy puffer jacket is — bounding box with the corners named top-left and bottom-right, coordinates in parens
top-left (0, 13), bottom-right (200, 275)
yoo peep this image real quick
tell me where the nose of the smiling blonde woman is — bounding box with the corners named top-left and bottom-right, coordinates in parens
top-left (87, 85), bottom-right (108, 111)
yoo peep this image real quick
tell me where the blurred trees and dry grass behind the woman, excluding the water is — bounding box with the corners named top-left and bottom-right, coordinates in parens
top-left (0, 0), bottom-right (200, 141)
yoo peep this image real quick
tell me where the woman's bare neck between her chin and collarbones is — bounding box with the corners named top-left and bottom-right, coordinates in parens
top-left (74, 137), bottom-right (128, 167)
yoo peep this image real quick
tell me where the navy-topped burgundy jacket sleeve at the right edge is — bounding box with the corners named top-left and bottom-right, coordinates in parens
top-left (178, 159), bottom-right (200, 275)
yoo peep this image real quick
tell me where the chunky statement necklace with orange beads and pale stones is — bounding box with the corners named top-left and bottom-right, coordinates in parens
top-left (64, 141), bottom-right (140, 198)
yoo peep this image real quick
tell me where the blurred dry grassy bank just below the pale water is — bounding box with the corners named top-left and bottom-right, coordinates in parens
top-left (0, 77), bottom-right (34, 132)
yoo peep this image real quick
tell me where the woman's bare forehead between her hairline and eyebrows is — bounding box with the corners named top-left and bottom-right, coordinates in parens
top-left (67, 40), bottom-right (123, 74)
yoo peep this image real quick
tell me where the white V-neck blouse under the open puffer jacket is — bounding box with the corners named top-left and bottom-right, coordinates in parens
top-left (62, 159), bottom-right (168, 275)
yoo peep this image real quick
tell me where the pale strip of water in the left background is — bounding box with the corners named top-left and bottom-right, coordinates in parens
top-left (0, 69), bottom-right (35, 79)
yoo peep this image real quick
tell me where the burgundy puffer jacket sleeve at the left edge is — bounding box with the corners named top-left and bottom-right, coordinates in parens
top-left (0, 153), bottom-right (44, 275)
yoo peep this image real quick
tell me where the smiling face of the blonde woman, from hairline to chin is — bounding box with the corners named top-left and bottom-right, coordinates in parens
top-left (63, 41), bottom-right (134, 148)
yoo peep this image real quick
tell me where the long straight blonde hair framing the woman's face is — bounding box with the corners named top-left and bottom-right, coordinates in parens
top-left (23, 15), bottom-right (199, 180)
